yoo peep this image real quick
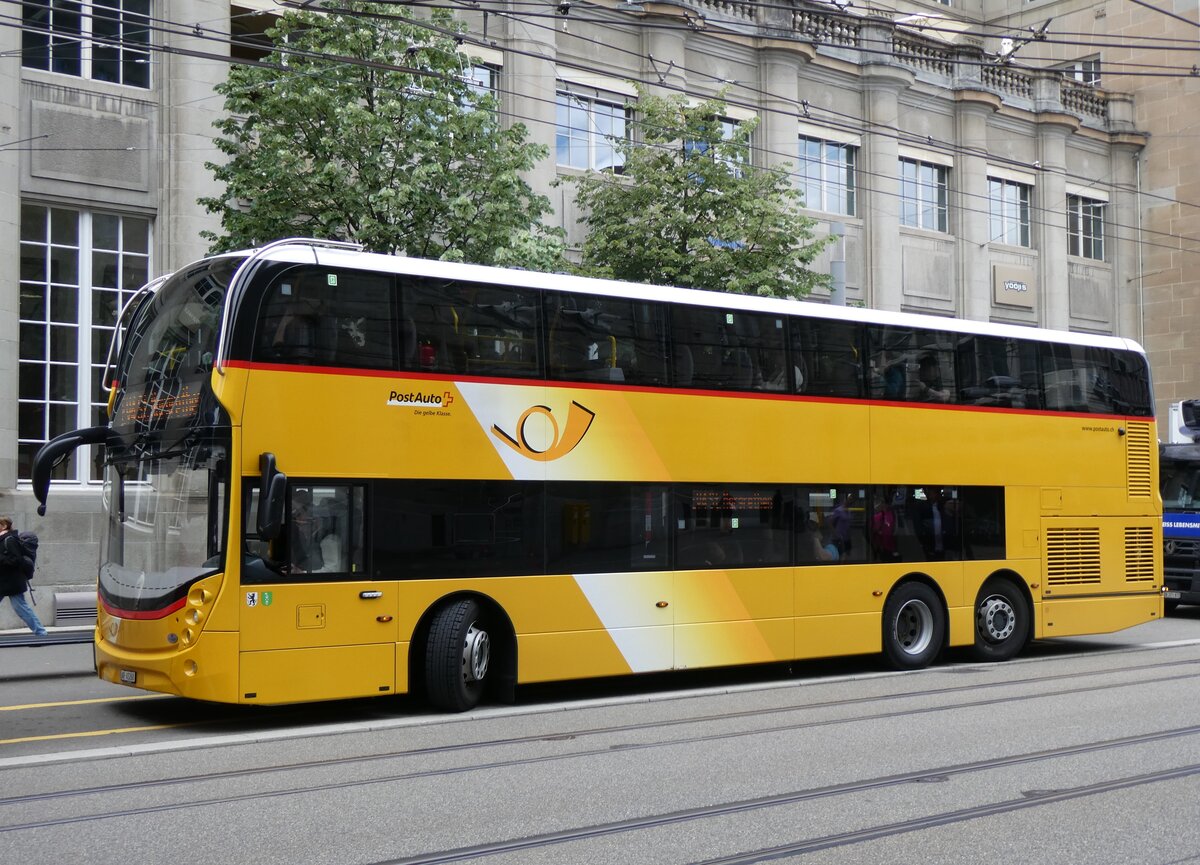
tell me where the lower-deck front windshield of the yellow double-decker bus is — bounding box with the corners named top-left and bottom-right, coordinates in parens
top-left (100, 440), bottom-right (229, 612)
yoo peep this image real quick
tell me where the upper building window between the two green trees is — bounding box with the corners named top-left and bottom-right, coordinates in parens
top-left (554, 85), bottom-right (630, 174)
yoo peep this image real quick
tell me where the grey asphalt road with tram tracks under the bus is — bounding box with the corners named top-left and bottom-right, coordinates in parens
top-left (0, 608), bottom-right (1200, 865)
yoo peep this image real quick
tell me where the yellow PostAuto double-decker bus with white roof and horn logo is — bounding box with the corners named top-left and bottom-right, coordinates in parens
top-left (34, 240), bottom-right (1163, 710)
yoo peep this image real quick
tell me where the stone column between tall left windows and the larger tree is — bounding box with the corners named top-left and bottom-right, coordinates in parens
top-left (160, 0), bottom-right (229, 274)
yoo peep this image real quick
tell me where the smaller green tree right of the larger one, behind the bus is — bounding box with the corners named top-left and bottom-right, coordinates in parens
top-left (569, 89), bottom-right (830, 298)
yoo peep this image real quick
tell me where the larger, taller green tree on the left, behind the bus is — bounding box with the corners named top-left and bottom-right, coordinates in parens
top-left (199, 2), bottom-right (563, 270)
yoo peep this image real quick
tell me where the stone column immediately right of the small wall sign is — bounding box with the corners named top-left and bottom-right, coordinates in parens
top-left (1031, 115), bottom-right (1079, 330)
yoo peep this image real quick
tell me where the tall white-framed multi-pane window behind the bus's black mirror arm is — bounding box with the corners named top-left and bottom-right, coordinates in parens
top-left (17, 204), bottom-right (150, 482)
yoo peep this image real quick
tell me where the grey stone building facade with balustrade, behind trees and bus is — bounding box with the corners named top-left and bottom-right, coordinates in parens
top-left (0, 0), bottom-right (1166, 627)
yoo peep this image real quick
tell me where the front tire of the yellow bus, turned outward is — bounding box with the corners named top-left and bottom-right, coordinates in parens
top-left (425, 599), bottom-right (492, 711)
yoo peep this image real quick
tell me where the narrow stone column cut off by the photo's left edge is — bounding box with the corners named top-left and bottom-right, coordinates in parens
top-left (0, 16), bottom-right (19, 489)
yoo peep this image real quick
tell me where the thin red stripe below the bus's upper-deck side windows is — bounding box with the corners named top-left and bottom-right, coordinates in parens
top-left (226, 360), bottom-right (1153, 422)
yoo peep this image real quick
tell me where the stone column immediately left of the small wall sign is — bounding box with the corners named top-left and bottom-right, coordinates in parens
top-left (950, 91), bottom-right (1000, 322)
